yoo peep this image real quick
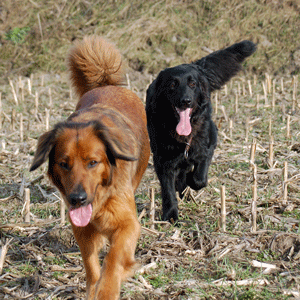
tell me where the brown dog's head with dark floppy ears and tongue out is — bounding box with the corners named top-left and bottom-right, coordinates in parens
top-left (30, 121), bottom-right (135, 226)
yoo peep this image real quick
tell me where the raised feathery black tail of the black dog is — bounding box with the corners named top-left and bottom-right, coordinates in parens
top-left (192, 41), bottom-right (256, 91)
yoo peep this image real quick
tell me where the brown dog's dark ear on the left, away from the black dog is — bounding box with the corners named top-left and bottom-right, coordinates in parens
top-left (30, 130), bottom-right (56, 172)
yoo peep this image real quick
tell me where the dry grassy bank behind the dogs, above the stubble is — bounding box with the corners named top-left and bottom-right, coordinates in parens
top-left (0, 0), bottom-right (300, 80)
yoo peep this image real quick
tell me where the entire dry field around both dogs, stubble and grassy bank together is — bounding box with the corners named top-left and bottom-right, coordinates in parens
top-left (0, 1), bottom-right (300, 300)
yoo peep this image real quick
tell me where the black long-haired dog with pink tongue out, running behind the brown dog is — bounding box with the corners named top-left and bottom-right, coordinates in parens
top-left (146, 41), bottom-right (256, 221)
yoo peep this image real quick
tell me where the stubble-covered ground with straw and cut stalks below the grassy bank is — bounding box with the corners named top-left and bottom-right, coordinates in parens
top-left (0, 71), bottom-right (300, 300)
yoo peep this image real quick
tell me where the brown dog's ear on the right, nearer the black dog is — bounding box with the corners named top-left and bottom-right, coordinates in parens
top-left (94, 122), bottom-right (137, 164)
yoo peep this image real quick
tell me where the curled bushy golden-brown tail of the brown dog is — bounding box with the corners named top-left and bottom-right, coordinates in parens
top-left (68, 35), bottom-right (124, 97)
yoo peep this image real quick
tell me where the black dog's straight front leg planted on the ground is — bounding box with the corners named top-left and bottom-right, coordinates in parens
top-left (155, 164), bottom-right (178, 221)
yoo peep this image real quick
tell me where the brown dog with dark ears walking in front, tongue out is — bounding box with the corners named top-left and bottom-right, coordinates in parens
top-left (30, 36), bottom-right (150, 299)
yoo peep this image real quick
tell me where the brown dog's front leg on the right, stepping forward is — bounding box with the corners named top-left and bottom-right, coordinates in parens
top-left (95, 217), bottom-right (140, 300)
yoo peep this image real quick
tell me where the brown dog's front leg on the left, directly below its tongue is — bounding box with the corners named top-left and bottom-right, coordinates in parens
top-left (72, 224), bottom-right (103, 300)
